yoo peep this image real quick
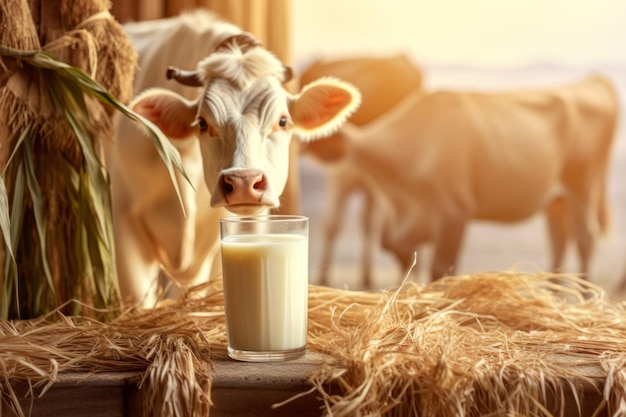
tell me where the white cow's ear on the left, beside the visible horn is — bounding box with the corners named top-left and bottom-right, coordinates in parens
top-left (130, 89), bottom-right (197, 139)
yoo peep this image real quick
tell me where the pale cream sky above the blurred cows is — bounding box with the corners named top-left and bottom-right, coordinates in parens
top-left (292, 0), bottom-right (626, 67)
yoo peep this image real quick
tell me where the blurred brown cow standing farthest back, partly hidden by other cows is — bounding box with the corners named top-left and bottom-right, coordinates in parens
top-left (299, 54), bottom-right (423, 287)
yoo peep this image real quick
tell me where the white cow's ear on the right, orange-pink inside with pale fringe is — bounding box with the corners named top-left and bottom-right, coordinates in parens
top-left (289, 77), bottom-right (361, 141)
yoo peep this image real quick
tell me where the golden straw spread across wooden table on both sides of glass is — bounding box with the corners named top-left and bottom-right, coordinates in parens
top-left (0, 271), bottom-right (626, 416)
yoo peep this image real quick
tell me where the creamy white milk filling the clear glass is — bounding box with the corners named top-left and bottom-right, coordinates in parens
top-left (222, 234), bottom-right (308, 351)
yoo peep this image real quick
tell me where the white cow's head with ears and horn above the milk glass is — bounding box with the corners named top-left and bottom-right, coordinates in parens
top-left (133, 35), bottom-right (360, 214)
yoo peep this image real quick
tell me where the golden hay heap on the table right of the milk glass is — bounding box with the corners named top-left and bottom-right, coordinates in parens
top-left (309, 273), bottom-right (626, 416)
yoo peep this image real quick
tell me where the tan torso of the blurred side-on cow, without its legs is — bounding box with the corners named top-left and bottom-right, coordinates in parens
top-left (354, 76), bottom-right (617, 222)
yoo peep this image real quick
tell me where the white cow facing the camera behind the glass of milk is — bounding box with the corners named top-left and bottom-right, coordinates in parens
top-left (106, 12), bottom-right (360, 307)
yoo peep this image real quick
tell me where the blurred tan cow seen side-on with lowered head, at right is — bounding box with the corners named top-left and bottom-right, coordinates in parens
top-left (330, 74), bottom-right (619, 279)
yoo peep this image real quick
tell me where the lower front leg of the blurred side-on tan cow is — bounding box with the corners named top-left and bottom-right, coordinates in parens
top-left (430, 218), bottom-right (467, 279)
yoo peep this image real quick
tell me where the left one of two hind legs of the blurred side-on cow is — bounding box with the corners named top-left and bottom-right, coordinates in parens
top-left (546, 196), bottom-right (571, 272)
